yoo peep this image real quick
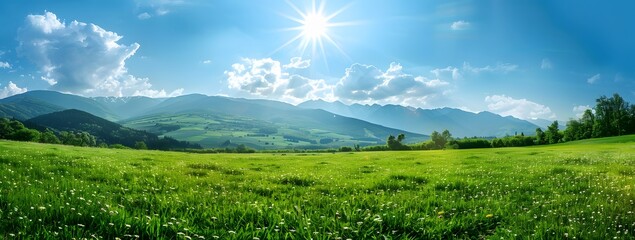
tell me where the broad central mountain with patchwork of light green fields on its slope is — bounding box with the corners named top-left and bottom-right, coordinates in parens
top-left (122, 95), bottom-right (428, 149)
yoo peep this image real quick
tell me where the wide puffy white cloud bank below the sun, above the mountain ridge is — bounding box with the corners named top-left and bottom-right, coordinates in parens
top-left (225, 58), bottom-right (449, 106)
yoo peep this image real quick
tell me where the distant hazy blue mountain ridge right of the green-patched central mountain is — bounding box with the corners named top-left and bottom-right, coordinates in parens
top-left (298, 100), bottom-right (538, 137)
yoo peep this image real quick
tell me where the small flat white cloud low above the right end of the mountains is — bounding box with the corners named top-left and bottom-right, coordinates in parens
top-left (485, 95), bottom-right (556, 119)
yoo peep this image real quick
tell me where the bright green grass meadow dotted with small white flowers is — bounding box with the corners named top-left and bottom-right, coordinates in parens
top-left (0, 136), bottom-right (635, 239)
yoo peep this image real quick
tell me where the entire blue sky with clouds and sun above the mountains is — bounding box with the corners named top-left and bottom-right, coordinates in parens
top-left (0, 0), bottom-right (635, 120)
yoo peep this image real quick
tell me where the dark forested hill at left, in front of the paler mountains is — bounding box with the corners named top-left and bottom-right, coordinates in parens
top-left (27, 109), bottom-right (197, 149)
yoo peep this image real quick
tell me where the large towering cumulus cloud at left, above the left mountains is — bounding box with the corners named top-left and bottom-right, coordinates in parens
top-left (18, 12), bottom-right (181, 96)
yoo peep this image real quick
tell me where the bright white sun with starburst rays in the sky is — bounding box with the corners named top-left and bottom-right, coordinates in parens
top-left (274, 0), bottom-right (354, 60)
